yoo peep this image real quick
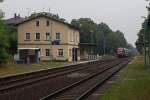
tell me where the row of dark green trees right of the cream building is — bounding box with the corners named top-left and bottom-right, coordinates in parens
top-left (71, 18), bottom-right (127, 55)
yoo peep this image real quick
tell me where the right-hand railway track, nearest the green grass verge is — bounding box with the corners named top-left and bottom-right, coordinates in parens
top-left (40, 60), bottom-right (129, 100)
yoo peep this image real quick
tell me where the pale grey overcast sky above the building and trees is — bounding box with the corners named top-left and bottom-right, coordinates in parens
top-left (0, 0), bottom-right (147, 44)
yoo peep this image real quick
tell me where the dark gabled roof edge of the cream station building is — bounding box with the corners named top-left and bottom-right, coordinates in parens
top-left (17, 12), bottom-right (79, 30)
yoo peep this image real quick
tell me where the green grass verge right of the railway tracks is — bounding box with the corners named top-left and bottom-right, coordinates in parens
top-left (101, 57), bottom-right (150, 100)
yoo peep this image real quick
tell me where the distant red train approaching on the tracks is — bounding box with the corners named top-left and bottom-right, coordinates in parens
top-left (116, 48), bottom-right (131, 58)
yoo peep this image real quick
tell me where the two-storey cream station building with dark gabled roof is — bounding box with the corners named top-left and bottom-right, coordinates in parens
top-left (18, 13), bottom-right (80, 63)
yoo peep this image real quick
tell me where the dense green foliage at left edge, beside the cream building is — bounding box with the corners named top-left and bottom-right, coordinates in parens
top-left (0, 16), bottom-right (17, 65)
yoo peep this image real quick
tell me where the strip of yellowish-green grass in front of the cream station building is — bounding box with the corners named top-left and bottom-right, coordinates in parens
top-left (0, 62), bottom-right (69, 77)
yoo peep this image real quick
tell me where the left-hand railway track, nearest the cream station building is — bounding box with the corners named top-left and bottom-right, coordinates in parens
top-left (0, 60), bottom-right (116, 93)
